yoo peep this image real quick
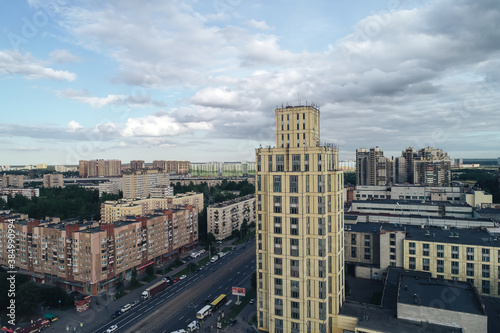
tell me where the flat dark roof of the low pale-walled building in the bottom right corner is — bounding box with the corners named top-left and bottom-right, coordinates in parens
top-left (398, 273), bottom-right (486, 316)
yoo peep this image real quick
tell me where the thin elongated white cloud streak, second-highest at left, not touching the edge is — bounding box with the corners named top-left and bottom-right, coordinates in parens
top-left (56, 88), bottom-right (165, 109)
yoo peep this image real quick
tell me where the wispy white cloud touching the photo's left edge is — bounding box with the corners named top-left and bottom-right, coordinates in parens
top-left (0, 50), bottom-right (76, 81)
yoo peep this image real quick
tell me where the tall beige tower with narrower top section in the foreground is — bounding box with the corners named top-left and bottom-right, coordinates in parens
top-left (256, 106), bottom-right (345, 332)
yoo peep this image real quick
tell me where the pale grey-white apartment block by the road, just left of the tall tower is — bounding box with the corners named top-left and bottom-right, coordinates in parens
top-left (207, 194), bottom-right (255, 240)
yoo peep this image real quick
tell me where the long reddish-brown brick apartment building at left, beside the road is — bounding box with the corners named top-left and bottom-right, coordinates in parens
top-left (0, 206), bottom-right (198, 295)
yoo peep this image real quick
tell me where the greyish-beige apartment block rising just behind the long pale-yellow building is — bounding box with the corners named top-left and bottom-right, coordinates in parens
top-left (122, 169), bottom-right (170, 199)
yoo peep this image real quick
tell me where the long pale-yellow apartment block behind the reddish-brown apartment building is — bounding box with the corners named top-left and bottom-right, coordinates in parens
top-left (101, 192), bottom-right (203, 223)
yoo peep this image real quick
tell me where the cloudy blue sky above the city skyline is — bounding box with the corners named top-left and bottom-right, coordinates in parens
top-left (0, 0), bottom-right (500, 165)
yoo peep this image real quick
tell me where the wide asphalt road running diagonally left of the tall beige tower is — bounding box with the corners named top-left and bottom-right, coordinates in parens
top-left (93, 242), bottom-right (255, 333)
